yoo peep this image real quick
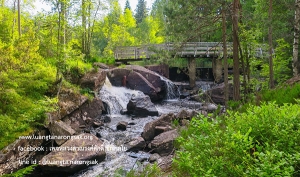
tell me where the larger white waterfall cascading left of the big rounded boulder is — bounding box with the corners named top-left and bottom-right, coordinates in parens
top-left (99, 77), bottom-right (143, 115)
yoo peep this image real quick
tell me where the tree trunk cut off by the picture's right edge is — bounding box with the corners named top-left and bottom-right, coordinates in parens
top-left (293, 0), bottom-right (300, 76)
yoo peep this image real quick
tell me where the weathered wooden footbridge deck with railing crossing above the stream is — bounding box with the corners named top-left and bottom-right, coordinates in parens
top-left (114, 42), bottom-right (263, 62)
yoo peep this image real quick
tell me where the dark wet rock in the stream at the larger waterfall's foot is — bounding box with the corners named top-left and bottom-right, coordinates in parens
top-left (127, 95), bottom-right (158, 117)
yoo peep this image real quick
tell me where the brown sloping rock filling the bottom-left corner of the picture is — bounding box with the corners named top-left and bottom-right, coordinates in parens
top-left (0, 129), bottom-right (51, 176)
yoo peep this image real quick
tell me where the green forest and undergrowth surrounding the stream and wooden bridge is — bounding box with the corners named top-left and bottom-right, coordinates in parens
top-left (0, 0), bottom-right (300, 176)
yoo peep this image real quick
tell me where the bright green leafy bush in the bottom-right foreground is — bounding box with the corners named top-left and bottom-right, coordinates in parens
top-left (173, 103), bottom-right (300, 177)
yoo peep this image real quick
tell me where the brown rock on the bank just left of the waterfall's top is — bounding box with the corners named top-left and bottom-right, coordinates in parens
top-left (80, 69), bottom-right (107, 92)
